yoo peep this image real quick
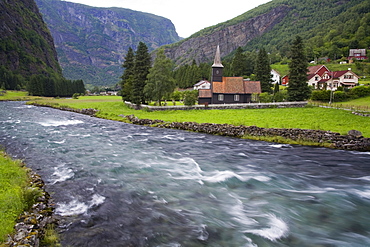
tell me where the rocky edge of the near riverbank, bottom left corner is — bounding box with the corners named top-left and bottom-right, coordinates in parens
top-left (5, 172), bottom-right (58, 247)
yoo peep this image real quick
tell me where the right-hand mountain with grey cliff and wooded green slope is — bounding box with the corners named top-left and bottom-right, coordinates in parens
top-left (165, 0), bottom-right (370, 65)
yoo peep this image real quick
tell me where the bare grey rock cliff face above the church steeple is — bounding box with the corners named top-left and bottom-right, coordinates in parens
top-left (165, 5), bottom-right (290, 65)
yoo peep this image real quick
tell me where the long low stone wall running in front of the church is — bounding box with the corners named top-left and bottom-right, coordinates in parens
top-left (125, 101), bottom-right (307, 111)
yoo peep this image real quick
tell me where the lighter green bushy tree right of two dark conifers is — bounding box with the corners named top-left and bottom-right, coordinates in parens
top-left (144, 49), bottom-right (175, 104)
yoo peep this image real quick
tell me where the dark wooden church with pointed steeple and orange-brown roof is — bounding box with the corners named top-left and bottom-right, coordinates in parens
top-left (198, 46), bottom-right (261, 104)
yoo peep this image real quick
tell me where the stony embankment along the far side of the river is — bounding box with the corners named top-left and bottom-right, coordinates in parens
top-left (32, 103), bottom-right (370, 151)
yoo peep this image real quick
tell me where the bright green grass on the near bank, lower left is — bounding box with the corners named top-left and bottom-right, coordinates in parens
top-left (0, 151), bottom-right (28, 244)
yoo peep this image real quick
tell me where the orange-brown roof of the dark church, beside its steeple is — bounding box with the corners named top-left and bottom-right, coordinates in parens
top-left (212, 77), bottom-right (261, 94)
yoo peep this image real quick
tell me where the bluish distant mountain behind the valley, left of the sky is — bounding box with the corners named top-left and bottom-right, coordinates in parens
top-left (36, 0), bottom-right (180, 85)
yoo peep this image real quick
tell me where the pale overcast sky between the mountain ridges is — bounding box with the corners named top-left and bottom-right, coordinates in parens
top-left (63, 0), bottom-right (271, 38)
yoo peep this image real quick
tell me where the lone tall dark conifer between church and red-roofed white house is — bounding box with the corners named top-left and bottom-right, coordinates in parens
top-left (288, 36), bottom-right (311, 101)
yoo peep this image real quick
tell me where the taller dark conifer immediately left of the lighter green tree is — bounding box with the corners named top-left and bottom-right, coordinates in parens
top-left (131, 42), bottom-right (151, 104)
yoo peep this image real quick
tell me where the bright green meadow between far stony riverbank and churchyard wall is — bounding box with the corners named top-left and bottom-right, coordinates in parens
top-left (28, 96), bottom-right (370, 137)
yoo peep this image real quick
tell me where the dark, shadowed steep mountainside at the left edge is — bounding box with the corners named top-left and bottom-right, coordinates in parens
top-left (0, 0), bottom-right (62, 81)
